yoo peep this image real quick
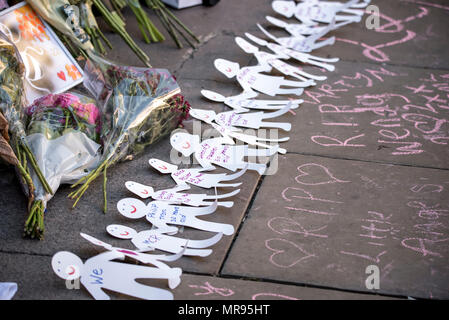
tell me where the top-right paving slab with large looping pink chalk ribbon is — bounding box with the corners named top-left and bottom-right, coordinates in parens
top-left (296, 0), bottom-right (449, 69)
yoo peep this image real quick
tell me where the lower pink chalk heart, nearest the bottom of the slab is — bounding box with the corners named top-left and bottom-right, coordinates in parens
top-left (265, 238), bottom-right (316, 268)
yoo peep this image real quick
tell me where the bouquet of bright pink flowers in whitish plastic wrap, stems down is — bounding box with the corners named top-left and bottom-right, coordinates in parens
top-left (21, 93), bottom-right (101, 238)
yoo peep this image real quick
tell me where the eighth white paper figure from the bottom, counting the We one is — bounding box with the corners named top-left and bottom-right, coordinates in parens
top-left (201, 90), bottom-right (304, 112)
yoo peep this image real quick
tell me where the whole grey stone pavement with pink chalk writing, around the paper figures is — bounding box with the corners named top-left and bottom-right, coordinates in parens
top-left (0, 0), bottom-right (449, 299)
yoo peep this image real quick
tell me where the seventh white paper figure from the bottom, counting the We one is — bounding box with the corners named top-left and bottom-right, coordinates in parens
top-left (189, 104), bottom-right (292, 131)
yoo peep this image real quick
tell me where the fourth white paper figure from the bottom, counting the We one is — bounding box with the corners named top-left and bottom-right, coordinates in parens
top-left (125, 181), bottom-right (240, 208)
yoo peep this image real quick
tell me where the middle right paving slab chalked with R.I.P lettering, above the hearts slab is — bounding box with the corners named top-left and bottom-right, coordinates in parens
top-left (273, 61), bottom-right (449, 168)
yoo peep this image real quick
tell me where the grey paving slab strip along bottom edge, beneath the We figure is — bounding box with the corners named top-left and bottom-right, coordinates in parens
top-left (0, 253), bottom-right (396, 300)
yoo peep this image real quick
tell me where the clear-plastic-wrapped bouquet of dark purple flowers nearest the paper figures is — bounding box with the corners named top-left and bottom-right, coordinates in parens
top-left (69, 57), bottom-right (190, 212)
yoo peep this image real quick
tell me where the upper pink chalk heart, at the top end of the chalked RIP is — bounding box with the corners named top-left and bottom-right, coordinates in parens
top-left (295, 163), bottom-right (351, 186)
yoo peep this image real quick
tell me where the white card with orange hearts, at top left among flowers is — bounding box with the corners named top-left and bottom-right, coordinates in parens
top-left (0, 2), bottom-right (83, 104)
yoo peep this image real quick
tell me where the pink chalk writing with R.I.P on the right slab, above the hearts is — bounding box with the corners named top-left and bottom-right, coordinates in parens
top-left (309, 67), bottom-right (449, 156)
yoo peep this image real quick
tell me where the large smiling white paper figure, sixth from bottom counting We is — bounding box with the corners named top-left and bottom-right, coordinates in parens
top-left (170, 132), bottom-right (279, 174)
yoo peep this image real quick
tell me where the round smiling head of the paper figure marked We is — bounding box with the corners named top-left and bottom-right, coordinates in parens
top-left (51, 251), bottom-right (83, 280)
